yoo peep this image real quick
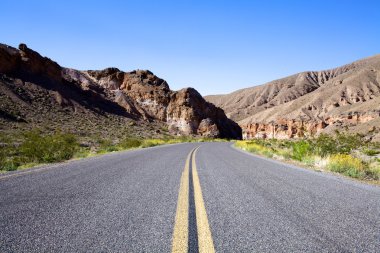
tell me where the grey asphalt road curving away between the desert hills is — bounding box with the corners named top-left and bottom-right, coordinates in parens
top-left (0, 143), bottom-right (380, 252)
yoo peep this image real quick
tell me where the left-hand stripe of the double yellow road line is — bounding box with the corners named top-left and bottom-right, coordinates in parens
top-left (172, 149), bottom-right (194, 253)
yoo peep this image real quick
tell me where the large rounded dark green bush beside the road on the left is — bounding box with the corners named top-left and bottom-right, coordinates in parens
top-left (18, 131), bottom-right (78, 163)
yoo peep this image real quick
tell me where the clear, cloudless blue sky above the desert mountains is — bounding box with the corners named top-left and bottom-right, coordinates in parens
top-left (0, 0), bottom-right (380, 95)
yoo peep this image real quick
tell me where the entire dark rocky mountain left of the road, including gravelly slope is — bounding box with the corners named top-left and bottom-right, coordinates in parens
top-left (0, 44), bottom-right (241, 139)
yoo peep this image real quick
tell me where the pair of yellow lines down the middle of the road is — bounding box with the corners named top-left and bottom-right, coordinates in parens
top-left (172, 147), bottom-right (215, 253)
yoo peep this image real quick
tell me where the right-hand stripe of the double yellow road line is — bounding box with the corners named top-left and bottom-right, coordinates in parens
top-left (192, 147), bottom-right (215, 253)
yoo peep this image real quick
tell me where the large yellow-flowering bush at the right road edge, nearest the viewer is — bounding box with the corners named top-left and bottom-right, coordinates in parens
top-left (327, 154), bottom-right (365, 178)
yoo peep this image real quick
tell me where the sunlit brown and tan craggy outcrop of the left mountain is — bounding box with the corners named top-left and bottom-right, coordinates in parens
top-left (62, 68), bottom-right (241, 138)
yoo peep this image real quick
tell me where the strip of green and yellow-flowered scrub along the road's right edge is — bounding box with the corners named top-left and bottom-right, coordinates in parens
top-left (235, 132), bottom-right (380, 181)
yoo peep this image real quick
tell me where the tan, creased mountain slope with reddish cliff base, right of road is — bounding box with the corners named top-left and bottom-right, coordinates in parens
top-left (205, 55), bottom-right (380, 141)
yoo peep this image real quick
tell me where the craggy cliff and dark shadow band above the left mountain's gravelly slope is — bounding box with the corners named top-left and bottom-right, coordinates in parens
top-left (0, 44), bottom-right (241, 139)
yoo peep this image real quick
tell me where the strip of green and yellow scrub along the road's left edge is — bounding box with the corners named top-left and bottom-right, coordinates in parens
top-left (0, 130), bottom-right (224, 172)
